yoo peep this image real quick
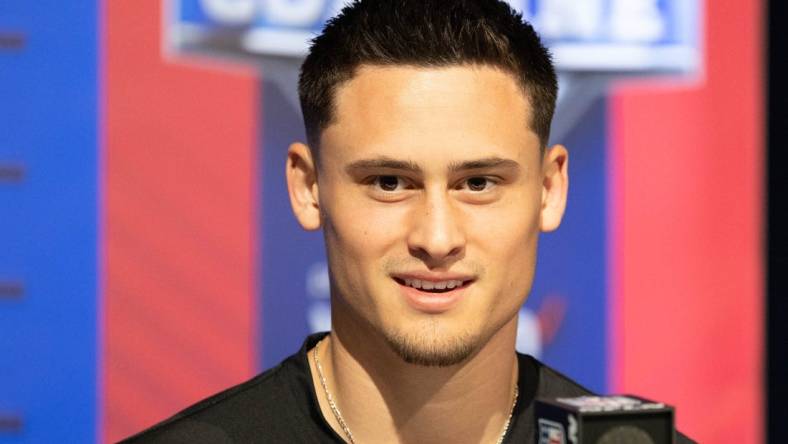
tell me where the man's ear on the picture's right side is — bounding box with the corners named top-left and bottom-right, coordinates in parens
top-left (540, 145), bottom-right (569, 232)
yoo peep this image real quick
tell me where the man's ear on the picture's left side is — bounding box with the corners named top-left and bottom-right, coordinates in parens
top-left (285, 143), bottom-right (320, 231)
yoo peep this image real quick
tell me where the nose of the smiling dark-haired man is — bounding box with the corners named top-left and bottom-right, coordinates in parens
top-left (408, 191), bottom-right (465, 268)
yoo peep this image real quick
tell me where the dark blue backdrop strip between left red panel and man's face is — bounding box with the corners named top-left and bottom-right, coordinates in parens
top-left (259, 77), bottom-right (325, 368)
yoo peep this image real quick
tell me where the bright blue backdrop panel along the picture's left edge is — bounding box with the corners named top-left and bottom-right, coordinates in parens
top-left (0, 0), bottom-right (98, 443)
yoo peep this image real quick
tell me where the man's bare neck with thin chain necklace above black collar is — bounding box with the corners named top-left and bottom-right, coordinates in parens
top-left (309, 312), bottom-right (517, 444)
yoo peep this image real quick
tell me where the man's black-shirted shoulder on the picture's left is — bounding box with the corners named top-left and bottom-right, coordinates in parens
top-left (122, 361), bottom-right (299, 443)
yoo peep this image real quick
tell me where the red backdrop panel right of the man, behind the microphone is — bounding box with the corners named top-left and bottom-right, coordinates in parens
top-left (610, 0), bottom-right (763, 443)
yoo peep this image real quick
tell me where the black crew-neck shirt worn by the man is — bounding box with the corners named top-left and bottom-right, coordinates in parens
top-left (123, 333), bottom-right (691, 444)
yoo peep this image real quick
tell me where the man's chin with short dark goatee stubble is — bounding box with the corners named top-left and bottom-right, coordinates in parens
top-left (383, 320), bottom-right (481, 367)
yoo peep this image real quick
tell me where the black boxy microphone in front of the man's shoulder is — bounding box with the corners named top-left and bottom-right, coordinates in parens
top-left (535, 395), bottom-right (676, 444)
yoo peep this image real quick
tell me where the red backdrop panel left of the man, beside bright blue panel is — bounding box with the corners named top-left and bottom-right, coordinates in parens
top-left (103, 0), bottom-right (258, 441)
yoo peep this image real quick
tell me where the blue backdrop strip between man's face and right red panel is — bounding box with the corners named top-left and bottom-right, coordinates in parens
top-left (526, 98), bottom-right (608, 392)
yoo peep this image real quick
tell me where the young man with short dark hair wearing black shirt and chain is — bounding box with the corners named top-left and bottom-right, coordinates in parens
top-left (126, 0), bottom-right (692, 443)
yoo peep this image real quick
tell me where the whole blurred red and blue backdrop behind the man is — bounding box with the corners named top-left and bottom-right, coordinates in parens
top-left (0, 0), bottom-right (776, 443)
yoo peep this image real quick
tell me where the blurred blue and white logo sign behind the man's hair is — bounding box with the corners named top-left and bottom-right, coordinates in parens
top-left (165, 0), bottom-right (698, 71)
